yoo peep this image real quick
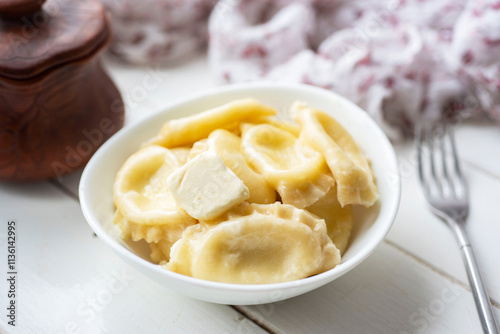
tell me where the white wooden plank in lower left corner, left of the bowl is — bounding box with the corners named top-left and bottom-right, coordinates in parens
top-left (0, 183), bottom-right (265, 334)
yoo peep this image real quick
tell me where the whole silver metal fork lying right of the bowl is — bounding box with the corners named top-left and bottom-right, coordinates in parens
top-left (416, 123), bottom-right (498, 334)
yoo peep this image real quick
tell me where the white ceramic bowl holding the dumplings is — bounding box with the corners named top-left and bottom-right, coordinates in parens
top-left (80, 83), bottom-right (400, 305)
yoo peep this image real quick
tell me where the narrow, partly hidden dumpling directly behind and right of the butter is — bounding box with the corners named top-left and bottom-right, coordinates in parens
top-left (208, 130), bottom-right (276, 204)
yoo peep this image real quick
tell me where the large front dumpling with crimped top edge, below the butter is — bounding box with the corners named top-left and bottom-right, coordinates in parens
top-left (166, 203), bottom-right (340, 284)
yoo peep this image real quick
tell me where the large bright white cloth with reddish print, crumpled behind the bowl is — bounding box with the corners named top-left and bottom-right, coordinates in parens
top-left (209, 0), bottom-right (500, 140)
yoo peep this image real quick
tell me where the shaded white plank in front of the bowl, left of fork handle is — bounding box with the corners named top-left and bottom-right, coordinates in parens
top-left (241, 244), bottom-right (500, 334)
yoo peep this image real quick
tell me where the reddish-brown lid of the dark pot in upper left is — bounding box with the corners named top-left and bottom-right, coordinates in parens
top-left (0, 0), bottom-right (110, 80)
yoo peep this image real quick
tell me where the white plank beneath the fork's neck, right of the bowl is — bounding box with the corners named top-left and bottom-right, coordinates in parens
top-left (388, 143), bottom-right (500, 302)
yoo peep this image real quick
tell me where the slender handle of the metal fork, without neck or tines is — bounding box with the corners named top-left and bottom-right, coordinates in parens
top-left (451, 221), bottom-right (499, 334)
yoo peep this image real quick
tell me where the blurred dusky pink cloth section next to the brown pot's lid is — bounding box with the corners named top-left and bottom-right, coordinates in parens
top-left (101, 0), bottom-right (216, 65)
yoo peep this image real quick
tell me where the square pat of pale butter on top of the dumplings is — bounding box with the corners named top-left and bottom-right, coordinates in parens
top-left (167, 151), bottom-right (250, 220)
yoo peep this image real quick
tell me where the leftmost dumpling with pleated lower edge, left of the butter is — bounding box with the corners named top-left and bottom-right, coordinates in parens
top-left (114, 145), bottom-right (197, 242)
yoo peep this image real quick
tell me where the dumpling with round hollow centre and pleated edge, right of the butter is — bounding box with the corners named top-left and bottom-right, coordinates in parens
top-left (242, 124), bottom-right (334, 208)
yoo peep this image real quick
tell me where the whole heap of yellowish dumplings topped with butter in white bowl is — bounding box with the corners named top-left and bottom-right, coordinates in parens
top-left (113, 99), bottom-right (378, 284)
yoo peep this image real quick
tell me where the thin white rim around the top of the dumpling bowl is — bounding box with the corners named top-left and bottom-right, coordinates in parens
top-left (78, 81), bottom-right (401, 292)
